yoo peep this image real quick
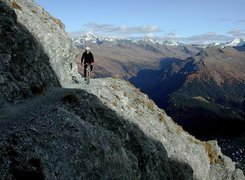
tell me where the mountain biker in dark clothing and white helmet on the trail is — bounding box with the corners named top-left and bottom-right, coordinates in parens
top-left (81, 47), bottom-right (94, 80)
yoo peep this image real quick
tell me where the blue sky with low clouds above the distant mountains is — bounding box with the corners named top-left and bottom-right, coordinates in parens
top-left (35, 0), bottom-right (245, 43)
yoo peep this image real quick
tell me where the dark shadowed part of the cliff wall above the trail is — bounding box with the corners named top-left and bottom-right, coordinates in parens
top-left (0, 1), bottom-right (60, 107)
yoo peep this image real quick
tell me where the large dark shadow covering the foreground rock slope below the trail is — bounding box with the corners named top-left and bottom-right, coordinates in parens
top-left (0, 88), bottom-right (193, 179)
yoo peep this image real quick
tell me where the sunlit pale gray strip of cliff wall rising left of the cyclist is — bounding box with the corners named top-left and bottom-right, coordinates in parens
top-left (6, 0), bottom-right (80, 85)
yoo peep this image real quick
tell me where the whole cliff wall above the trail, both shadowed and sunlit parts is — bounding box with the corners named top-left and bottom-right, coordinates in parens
top-left (0, 0), bottom-right (80, 106)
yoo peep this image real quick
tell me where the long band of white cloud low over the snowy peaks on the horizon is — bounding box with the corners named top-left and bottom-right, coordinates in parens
top-left (70, 23), bottom-right (245, 44)
